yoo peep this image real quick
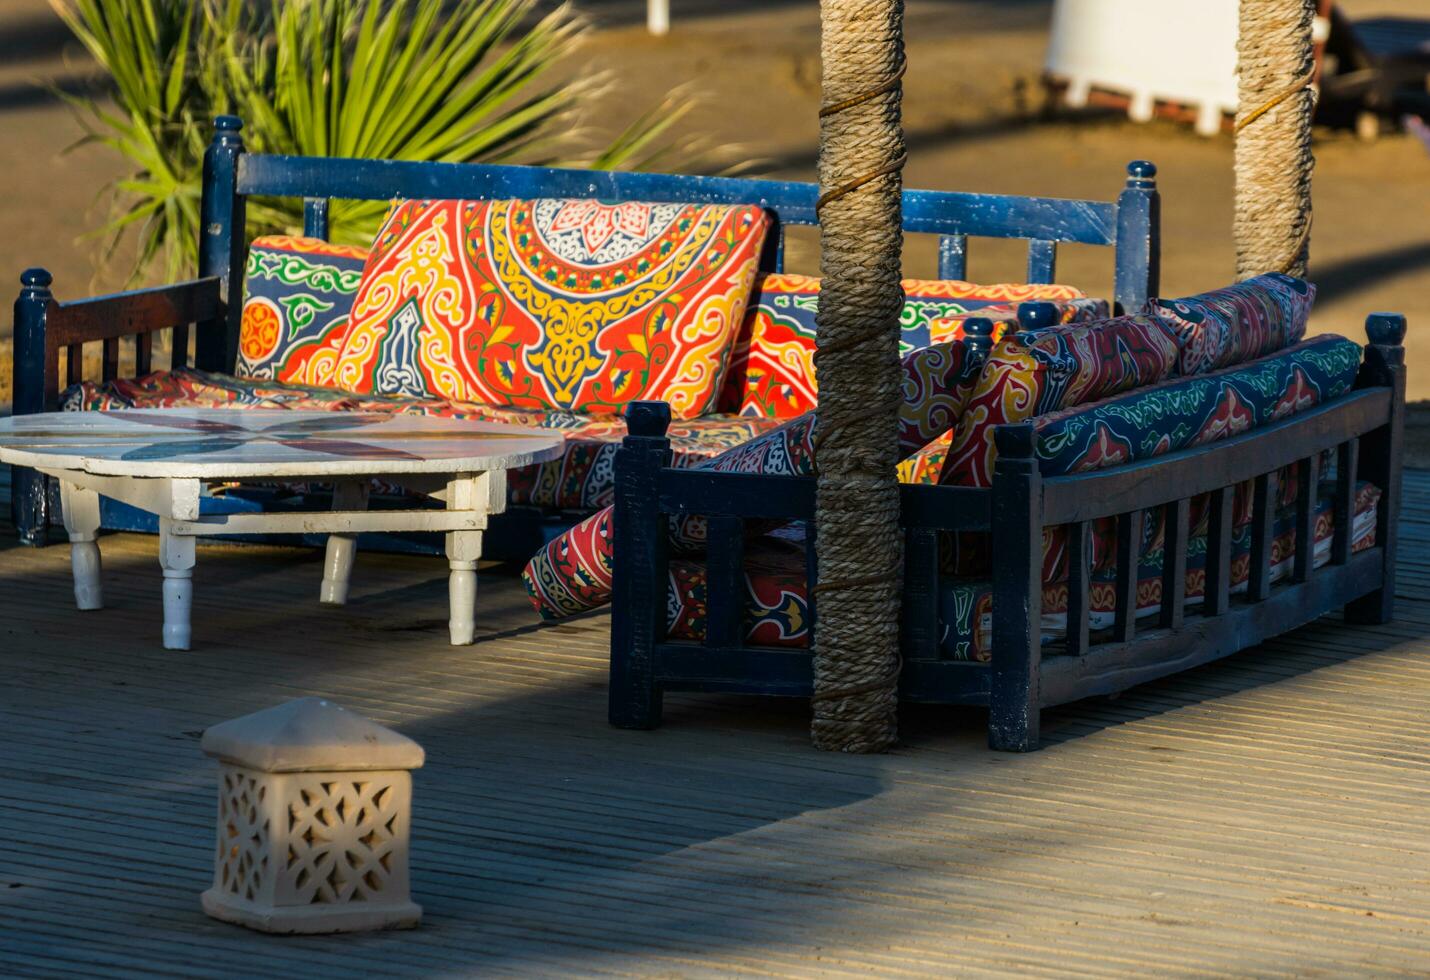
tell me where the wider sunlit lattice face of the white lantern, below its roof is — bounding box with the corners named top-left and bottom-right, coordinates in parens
top-left (276, 773), bottom-right (406, 906)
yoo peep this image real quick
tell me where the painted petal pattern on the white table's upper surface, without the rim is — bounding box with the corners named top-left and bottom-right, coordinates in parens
top-left (0, 409), bottom-right (538, 462)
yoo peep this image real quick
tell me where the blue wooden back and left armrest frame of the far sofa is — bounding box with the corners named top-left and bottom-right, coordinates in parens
top-left (13, 116), bottom-right (1160, 545)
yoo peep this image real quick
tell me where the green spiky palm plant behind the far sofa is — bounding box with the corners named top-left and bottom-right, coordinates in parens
top-left (50, 0), bottom-right (688, 279)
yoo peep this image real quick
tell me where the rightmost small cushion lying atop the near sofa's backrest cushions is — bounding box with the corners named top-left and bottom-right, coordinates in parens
top-left (1148, 272), bottom-right (1316, 375)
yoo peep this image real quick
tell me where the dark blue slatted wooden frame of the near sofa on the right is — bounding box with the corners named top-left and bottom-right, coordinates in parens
top-left (609, 313), bottom-right (1406, 751)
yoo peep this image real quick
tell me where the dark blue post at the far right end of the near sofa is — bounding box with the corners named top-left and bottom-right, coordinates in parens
top-left (1344, 313), bottom-right (1406, 624)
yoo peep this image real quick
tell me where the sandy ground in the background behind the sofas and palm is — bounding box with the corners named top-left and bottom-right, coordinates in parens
top-left (0, 0), bottom-right (1430, 401)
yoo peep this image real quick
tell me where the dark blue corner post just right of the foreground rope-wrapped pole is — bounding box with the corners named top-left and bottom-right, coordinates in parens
top-left (988, 422), bottom-right (1042, 753)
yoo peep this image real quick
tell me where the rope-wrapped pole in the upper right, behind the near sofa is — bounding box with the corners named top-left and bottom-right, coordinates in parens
top-left (1234, 0), bottom-right (1316, 279)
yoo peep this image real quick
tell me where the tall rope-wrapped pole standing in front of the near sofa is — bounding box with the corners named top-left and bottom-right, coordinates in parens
top-left (811, 0), bottom-right (905, 753)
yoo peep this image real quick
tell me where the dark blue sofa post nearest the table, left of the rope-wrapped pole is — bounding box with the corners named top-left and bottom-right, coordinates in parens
top-left (608, 402), bottom-right (671, 728)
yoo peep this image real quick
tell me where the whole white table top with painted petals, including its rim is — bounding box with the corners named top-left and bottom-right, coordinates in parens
top-left (0, 408), bottom-right (562, 479)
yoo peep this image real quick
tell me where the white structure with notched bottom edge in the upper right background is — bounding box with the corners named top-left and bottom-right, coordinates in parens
top-left (1044, 0), bottom-right (1330, 136)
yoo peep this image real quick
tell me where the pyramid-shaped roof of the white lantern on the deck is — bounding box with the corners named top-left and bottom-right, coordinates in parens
top-left (200, 698), bottom-right (425, 773)
